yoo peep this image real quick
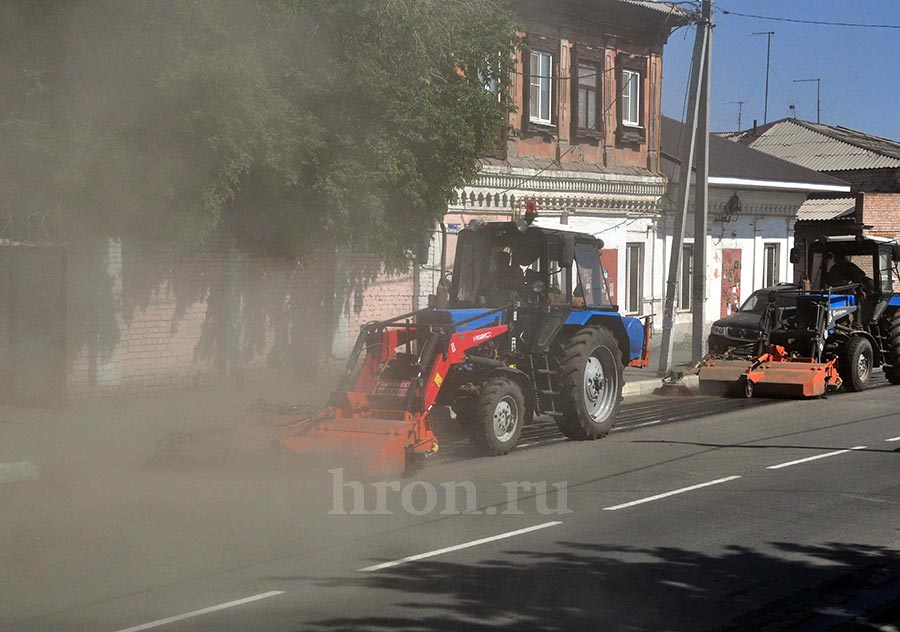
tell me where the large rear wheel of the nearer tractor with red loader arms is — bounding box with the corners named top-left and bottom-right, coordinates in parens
top-left (556, 327), bottom-right (624, 441)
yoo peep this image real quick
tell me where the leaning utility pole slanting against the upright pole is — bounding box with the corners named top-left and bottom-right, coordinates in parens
top-left (659, 0), bottom-right (712, 376)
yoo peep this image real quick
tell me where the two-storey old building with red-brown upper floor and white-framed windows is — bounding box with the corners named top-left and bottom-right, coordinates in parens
top-left (421, 0), bottom-right (689, 315)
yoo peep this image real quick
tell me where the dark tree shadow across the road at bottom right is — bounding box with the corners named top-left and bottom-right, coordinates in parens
top-left (304, 542), bottom-right (900, 632)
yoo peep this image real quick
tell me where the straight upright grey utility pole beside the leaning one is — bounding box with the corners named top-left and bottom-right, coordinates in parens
top-left (682, 0), bottom-right (712, 363)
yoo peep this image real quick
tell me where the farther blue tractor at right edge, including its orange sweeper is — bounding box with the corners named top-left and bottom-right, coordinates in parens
top-left (699, 235), bottom-right (900, 397)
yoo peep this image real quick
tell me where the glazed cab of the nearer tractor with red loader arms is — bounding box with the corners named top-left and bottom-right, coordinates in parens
top-left (450, 222), bottom-right (616, 311)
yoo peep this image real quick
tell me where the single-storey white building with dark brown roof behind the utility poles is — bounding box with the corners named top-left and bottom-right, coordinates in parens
top-left (647, 117), bottom-right (850, 341)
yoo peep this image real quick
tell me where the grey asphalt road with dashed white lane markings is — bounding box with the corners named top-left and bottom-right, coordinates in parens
top-left (0, 382), bottom-right (900, 632)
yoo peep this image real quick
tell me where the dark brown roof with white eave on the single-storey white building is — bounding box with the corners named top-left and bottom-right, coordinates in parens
top-left (661, 116), bottom-right (850, 192)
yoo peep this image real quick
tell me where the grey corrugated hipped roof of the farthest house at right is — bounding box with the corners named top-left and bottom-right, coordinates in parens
top-left (723, 119), bottom-right (900, 171)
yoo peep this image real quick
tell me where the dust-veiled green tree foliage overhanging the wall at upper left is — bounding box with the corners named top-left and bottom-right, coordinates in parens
top-left (0, 0), bottom-right (516, 262)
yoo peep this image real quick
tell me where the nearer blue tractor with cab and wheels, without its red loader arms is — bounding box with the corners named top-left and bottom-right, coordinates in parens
top-left (432, 216), bottom-right (651, 455)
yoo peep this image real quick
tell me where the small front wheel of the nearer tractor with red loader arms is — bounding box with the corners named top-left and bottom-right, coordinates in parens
top-left (461, 377), bottom-right (525, 456)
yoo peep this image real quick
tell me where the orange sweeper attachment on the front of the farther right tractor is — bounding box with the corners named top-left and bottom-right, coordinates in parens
top-left (698, 345), bottom-right (841, 397)
